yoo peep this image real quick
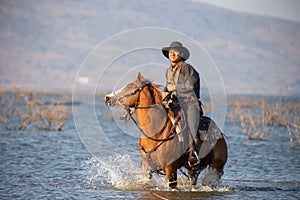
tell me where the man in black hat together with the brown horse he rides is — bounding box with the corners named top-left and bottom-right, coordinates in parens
top-left (105, 42), bottom-right (228, 189)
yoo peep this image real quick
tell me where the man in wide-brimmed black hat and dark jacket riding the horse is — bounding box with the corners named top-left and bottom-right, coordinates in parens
top-left (162, 41), bottom-right (203, 164)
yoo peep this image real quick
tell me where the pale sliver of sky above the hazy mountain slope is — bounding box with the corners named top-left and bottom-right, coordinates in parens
top-left (196, 0), bottom-right (300, 22)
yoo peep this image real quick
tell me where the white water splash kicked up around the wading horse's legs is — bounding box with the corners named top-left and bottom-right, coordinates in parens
top-left (86, 154), bottom-right (231, 192)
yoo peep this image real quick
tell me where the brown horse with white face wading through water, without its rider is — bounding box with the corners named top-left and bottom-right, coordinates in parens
top-left (105, 73), bottom-right (227, 188)
